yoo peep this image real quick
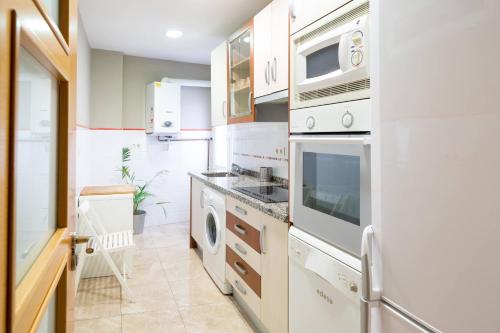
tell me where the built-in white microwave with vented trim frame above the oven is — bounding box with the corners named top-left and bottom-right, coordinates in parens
top-left (290, 0), bottom-right (370, 109)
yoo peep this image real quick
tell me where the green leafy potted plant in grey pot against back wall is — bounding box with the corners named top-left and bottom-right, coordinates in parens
top-left (120, 147), bottom-right (168, 235)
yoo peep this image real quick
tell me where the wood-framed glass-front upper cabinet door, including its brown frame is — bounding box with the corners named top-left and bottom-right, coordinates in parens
top-left (229, 22), bottom-right (254, 123)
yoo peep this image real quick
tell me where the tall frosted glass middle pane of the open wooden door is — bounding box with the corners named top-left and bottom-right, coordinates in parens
top-left (14, 48), bottom-right (58, 284)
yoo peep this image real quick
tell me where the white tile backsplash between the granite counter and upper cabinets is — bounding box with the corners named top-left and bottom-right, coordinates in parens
top-left (229, 122), bottom-right (288, 179)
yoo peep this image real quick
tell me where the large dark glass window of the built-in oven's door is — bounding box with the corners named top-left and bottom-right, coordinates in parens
top-left (302, 152), bottom-right (360, 226)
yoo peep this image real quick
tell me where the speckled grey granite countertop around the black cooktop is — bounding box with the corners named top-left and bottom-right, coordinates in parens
top-left (188, 172), bottom-right (288, 223)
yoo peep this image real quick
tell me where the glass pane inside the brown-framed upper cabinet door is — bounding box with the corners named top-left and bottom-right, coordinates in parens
top-left (230, 30), bottom-right (252, 117)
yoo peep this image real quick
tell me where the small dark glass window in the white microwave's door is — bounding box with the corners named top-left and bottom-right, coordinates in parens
top-left (306, 43), bottom-right (340, 79)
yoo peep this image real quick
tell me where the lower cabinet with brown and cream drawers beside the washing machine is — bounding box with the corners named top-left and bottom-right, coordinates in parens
top-left (226, 197), bottom-right (288, 332)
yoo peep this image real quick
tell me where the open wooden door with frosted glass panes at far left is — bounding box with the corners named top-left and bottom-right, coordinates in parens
top-left (0, 0), bottom-right (77, 333)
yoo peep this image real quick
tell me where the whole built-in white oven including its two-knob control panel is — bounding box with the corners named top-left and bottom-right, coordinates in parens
top-left (290, 100), bottom-right (371, 257)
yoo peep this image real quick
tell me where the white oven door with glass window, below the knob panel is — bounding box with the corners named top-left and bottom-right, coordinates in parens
top-left (290, 135), bottom-right (371, 257)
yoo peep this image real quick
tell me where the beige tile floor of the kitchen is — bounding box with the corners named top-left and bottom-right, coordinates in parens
top-left (75, 223), bottom-right (254, 333)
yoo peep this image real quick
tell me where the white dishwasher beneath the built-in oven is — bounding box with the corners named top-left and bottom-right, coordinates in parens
top-left (288, 227), bottom-right (361, 333)
